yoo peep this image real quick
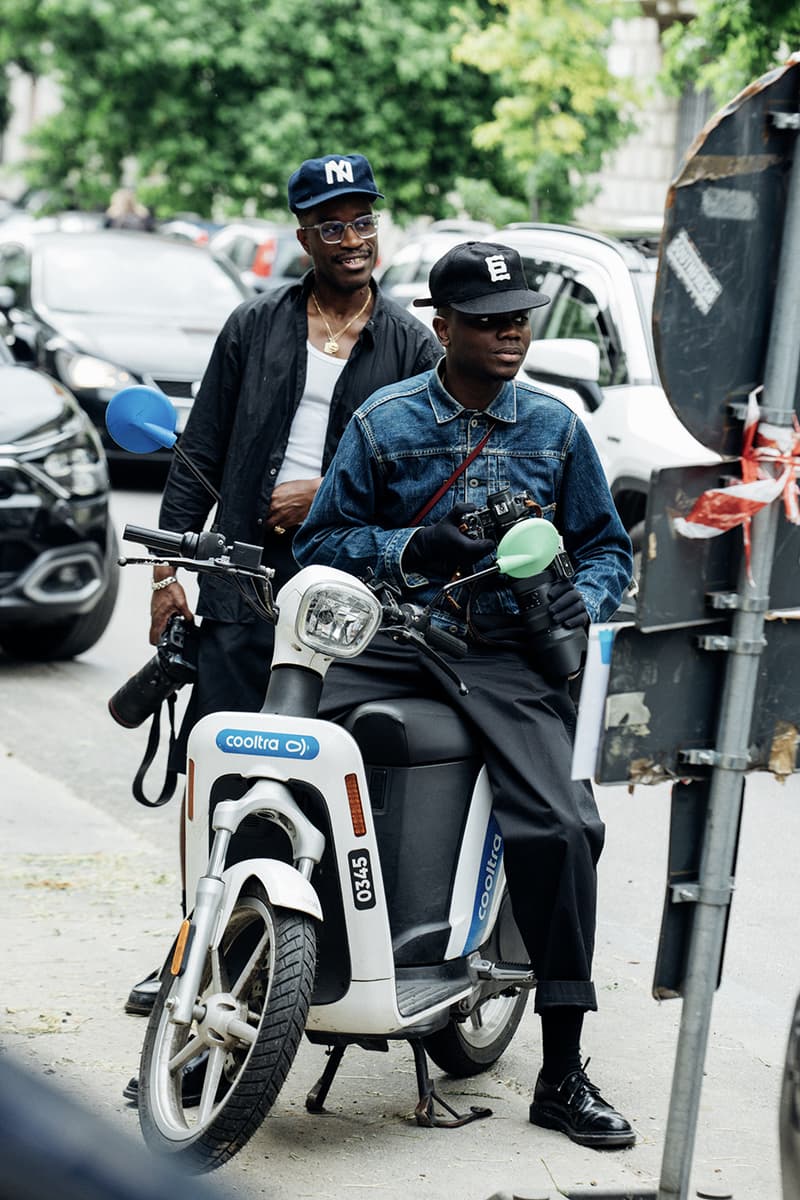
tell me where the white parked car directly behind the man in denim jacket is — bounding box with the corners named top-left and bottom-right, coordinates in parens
top-left (398, 224), bottom-right (718, 550)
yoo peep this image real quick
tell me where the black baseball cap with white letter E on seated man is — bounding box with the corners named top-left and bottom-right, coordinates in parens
top-left (414, 241), bottom-right (551, 316)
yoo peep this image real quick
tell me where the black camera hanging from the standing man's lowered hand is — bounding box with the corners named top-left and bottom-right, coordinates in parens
top-left (108, 613), bottom-right (197, 730)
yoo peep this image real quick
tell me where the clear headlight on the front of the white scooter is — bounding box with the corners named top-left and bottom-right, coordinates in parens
top-left (295, 583), bottom-right (380, 659)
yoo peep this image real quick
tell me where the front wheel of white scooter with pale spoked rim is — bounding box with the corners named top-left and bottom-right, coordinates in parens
top-left (139, 887), bottom-right (317, 1171)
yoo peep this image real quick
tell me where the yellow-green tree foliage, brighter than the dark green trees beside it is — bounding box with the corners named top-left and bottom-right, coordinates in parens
top-left (455, 0), bottom-right (634, 221)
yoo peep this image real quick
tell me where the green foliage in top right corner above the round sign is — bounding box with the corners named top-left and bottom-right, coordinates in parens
top-left (663, 0), bottom-right (800, 104)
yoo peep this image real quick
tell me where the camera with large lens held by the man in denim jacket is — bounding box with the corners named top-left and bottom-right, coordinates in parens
top-left (462, 488), bottom-right (589, 677)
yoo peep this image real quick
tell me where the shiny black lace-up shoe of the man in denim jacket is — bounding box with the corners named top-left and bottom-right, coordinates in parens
top-left (530, 1060), bottom-right (636, 1150)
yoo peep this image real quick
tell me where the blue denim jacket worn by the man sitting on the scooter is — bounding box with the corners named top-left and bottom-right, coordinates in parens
top-left (294, 368), bottom-right (632, 632)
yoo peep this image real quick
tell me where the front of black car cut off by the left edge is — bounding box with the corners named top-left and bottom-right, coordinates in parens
top-left (0, 338), bottom-right (120, 661)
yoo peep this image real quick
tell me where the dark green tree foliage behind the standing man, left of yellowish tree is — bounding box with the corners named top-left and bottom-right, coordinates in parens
top-left (0, 0), bottom-right (513, 216)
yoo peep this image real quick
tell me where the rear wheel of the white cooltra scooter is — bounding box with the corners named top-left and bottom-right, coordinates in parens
top-left (423, 990), bottom-right (529, 1079)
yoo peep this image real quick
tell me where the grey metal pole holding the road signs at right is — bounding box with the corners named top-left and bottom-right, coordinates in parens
top-left (658, 117), bottom-right (800, 1200)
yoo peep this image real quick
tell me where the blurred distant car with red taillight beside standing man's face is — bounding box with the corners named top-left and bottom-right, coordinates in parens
top-left (209, 220), bottom-right (311, 292)
